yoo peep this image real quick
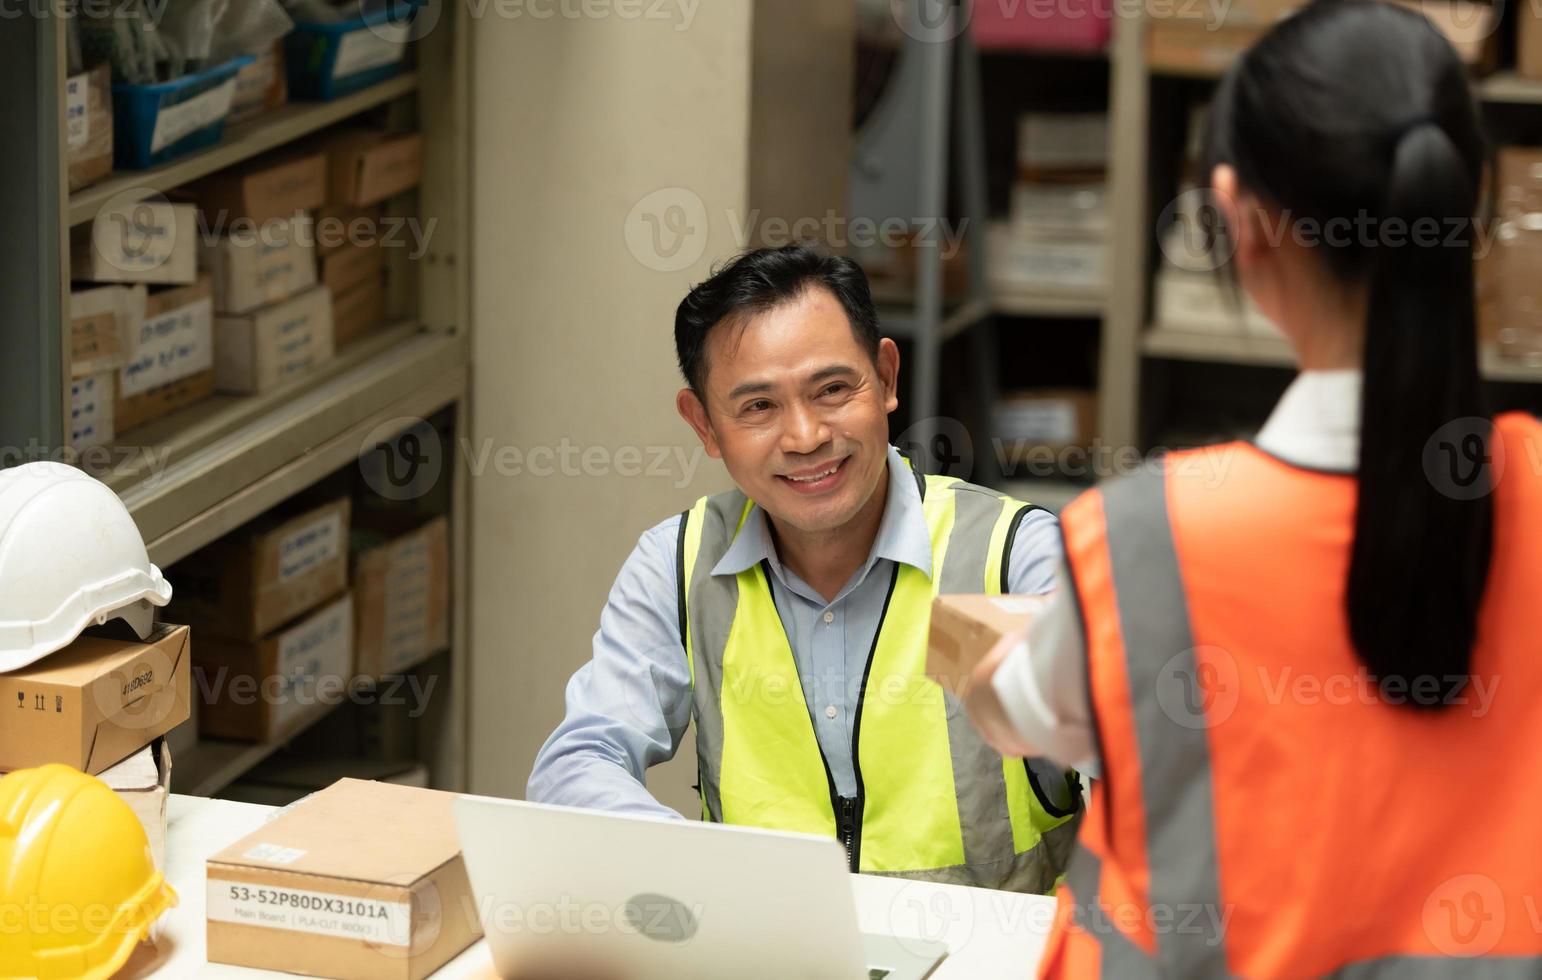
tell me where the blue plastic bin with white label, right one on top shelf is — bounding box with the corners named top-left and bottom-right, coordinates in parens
top-left (284, 0), bottom-right (421, 102)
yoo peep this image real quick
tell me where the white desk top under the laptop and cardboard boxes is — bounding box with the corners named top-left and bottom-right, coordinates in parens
top-left (119, 795), bottom-right (1055, 980)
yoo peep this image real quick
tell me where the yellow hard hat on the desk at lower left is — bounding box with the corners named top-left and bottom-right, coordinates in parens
top-left (0, 766), bottom-right (177, 980)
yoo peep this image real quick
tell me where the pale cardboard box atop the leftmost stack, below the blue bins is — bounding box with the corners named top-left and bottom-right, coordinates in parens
top-left (69, 200), bottom-right (197, 285)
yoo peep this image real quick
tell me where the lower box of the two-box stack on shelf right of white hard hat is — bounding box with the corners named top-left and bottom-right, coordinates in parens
top-left (193, 592), bottom-right (353, 741)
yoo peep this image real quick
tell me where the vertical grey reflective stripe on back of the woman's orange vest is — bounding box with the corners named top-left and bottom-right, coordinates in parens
top-left (1103, 470), bottom-right (1227, 978)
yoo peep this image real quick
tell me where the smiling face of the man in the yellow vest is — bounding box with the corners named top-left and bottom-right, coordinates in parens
top-left (677, 288), bottom-right (899, 532)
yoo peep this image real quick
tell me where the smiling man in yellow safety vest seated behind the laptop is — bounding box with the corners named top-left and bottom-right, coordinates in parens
top-left (529, 245), bottom-right (1081, 892)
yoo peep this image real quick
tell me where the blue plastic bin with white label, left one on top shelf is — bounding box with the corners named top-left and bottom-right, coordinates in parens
top-left (113, 54), bottom-right (256, 169)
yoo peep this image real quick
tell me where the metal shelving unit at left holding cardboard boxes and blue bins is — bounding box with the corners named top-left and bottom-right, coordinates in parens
top-left (0, 8), bottom-right (470, 795)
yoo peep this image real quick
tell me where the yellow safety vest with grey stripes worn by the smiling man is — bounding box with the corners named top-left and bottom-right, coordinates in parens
top-left (678, 476), bottom-right (1079, 892)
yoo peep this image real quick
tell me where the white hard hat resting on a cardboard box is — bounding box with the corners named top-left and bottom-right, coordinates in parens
top-left (0, 462), bottom-right (171, 673)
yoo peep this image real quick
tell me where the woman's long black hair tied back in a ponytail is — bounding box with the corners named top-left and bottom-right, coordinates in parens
top-left (1206, 0), bottom-right (1493, 707)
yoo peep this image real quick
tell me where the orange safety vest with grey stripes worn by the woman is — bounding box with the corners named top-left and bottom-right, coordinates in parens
top-left (1039, 414), bottom-right (1542, 980)
